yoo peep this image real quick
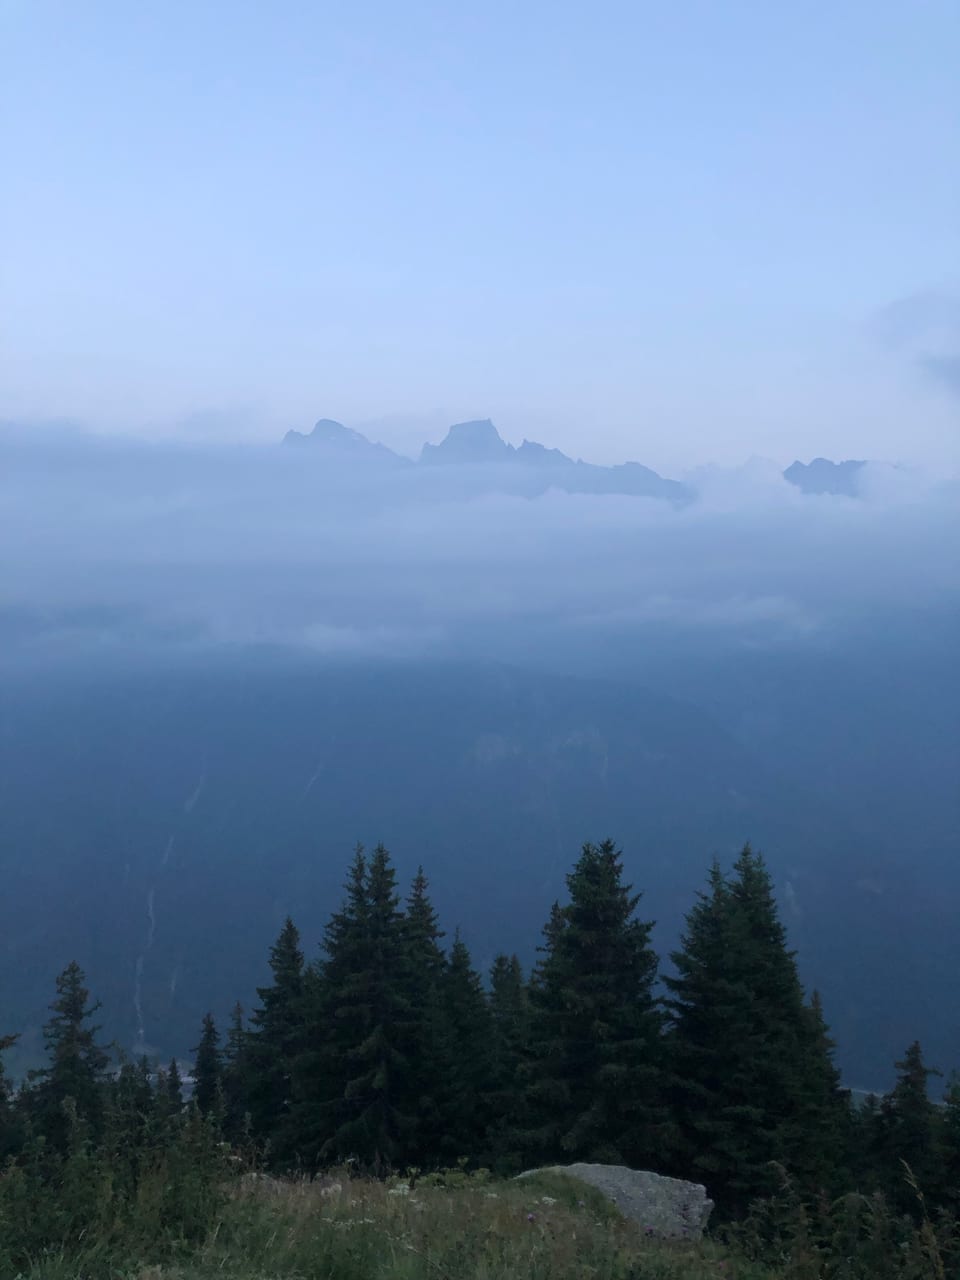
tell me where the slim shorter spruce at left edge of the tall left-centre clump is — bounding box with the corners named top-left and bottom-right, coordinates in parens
top-left (243, 916), bottom-right (305, 1166)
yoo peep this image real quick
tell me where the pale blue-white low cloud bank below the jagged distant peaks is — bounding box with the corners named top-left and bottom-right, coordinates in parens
top-left (0, 430), bottom-right (960, 662)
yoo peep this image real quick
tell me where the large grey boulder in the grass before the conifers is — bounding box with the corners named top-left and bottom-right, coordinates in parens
top-left (520, 1165), bottom-right (713, 1240)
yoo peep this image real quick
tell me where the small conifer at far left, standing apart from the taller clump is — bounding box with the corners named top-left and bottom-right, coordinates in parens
top-left (31, 960), bottom-right (110, 1152)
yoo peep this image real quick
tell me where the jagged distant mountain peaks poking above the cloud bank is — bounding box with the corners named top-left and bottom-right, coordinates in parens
top-left (283, 417), bottom-right (865, 507)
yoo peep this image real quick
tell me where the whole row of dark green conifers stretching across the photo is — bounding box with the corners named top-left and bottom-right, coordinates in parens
top-left (0, 841), bottom-right (960, 1219)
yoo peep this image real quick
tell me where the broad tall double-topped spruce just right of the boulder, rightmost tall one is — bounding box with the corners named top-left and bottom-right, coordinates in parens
top-left (666, 845), bottom-right (836, 1213)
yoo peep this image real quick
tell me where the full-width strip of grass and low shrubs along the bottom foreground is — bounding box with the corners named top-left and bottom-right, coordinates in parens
top-left (0, 1170), bottom-right (960, 1280)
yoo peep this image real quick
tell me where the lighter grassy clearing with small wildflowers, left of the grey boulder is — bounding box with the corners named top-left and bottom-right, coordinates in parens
top-left (1, 1171), bottom-right (771, 1280)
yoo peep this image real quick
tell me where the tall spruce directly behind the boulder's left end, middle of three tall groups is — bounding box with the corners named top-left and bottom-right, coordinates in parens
top-left (527, 840), bottom-right (666, 1165)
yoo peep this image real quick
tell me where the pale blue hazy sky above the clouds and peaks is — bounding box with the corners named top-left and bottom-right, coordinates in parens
top-left (0, 0), bottom-right (960, 466)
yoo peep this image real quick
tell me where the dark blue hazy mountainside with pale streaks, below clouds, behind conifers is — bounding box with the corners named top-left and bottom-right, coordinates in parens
top-left (0, 654), bottom-right (956, 1084)
